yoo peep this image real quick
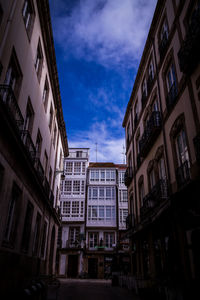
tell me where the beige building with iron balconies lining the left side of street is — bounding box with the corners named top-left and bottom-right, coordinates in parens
top-left (0, 0), bottom-right (68, 298)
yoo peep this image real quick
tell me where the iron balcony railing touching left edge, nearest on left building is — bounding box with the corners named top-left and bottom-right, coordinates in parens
top-left (0, 85), bottom-right (24, 130)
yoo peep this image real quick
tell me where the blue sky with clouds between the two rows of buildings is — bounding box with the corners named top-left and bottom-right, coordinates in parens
top-left (49, 0), bottom-right (157, 163)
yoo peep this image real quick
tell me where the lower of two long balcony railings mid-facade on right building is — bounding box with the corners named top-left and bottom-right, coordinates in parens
top-left (140, 179), bottom-right (169, 221)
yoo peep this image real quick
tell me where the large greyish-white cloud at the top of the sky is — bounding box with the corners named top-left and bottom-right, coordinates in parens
top-left (52, 0), bottom-right (156, 68)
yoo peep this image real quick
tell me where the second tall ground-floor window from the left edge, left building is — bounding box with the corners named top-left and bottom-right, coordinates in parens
top-left (21, 202), bottom-right (33, 252)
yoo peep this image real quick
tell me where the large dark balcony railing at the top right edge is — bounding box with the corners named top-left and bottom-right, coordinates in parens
top-left (178, 8), bottom-right (200, 74)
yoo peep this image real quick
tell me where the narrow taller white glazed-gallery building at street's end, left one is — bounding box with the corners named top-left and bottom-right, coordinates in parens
top-left (58, 148), bottom-right (89, 278)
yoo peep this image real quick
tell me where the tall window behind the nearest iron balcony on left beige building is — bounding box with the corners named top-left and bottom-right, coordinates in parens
top-left (4, 49), bottom-right (22, 98)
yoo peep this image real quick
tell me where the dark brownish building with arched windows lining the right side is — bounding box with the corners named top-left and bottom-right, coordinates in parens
top-left (123, 0), bottom-right (200, 299)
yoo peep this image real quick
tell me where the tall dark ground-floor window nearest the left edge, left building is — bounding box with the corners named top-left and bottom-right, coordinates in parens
top-left (4, 184), bottom-right (21, 246)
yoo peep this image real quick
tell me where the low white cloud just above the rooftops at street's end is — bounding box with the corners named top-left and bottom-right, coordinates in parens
top-left (69, 122), bottom-right (125, 163)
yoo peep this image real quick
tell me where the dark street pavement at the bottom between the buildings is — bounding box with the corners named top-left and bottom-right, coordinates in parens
top-left (47, 279), bottom-right (141, 300)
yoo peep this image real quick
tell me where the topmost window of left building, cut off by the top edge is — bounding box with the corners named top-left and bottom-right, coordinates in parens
top-left (22, 0), bottom-right (35, 38)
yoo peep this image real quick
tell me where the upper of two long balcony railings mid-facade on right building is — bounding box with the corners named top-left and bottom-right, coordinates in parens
top-left (139, 111), bottom-right (161, 157)
